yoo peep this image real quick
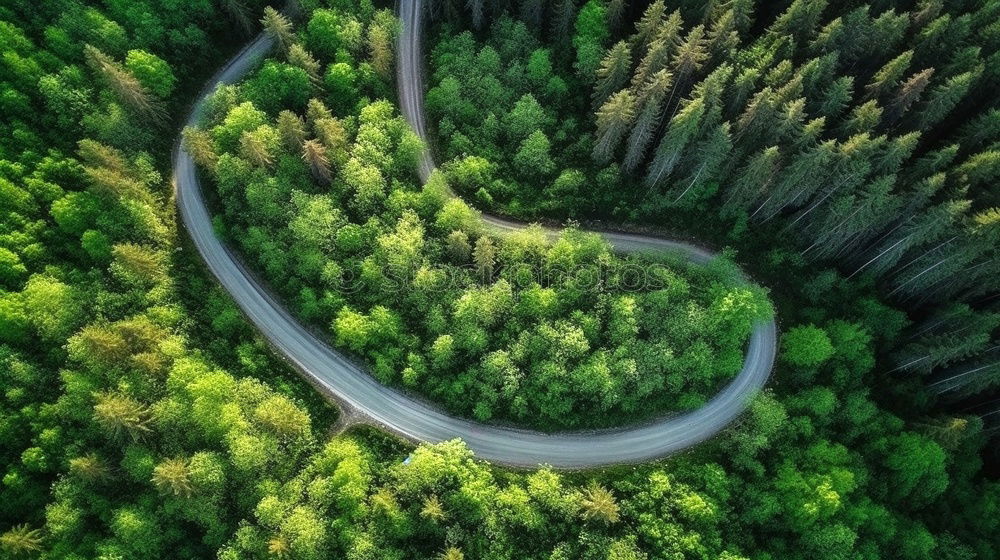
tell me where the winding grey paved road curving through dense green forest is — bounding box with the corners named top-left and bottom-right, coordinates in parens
top-left (173, 0), bottom-right (777, 469)
